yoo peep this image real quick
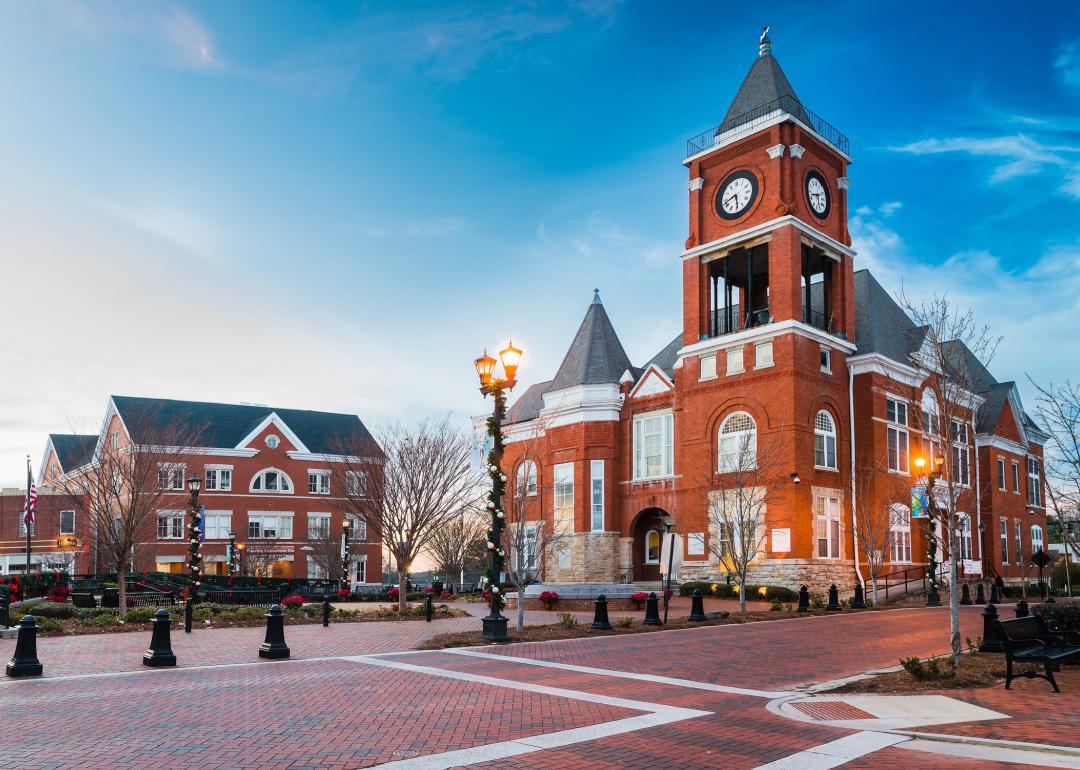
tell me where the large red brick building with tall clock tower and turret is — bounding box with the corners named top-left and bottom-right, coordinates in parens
top-left (505, 34), bottom-right (1047, 587)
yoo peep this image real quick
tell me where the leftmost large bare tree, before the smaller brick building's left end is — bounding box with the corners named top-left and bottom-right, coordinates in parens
top-left (49, 409), bottom-right (203, 616)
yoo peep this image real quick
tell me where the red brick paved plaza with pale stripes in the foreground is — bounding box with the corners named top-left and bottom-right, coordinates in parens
top-left (0, 608), bottom-right (1080, 770)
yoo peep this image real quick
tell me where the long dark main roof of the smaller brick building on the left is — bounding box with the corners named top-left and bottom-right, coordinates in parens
top-left (111, 395), bottom-right (382, 457)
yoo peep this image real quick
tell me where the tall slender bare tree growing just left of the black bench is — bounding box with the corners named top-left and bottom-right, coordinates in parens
top-left (901, 294), bottom-right (1001, 665)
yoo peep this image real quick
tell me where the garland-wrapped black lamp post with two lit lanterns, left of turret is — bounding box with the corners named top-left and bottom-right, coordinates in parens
top-left (475, 340), bottom-right (524, 641)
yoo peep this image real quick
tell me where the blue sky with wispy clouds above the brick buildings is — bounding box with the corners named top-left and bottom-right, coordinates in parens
top-left (0, 0), bottom-right (1080, 486)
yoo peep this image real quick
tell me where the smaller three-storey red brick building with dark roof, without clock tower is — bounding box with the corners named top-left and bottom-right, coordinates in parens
top-left (39, 396), bottom-right (383, 583)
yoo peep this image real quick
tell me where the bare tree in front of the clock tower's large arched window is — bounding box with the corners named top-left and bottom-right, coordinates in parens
top-left (707, 431), bottom-right (789, 612)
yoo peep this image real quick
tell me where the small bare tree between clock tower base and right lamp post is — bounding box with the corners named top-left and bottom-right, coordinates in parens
top-left (854, 456), bottom-right (912, 605)
